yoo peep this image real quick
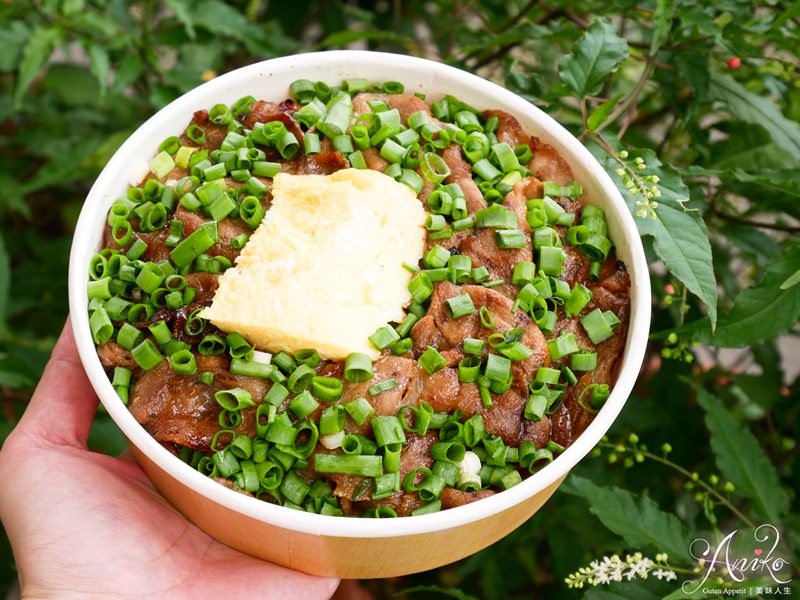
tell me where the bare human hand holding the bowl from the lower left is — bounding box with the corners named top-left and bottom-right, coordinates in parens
top-left (0, 321), bottom-right (337, 600)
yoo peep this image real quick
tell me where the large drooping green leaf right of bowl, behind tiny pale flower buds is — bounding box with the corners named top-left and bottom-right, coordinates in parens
top-left (606, 150), bottom-right (717, 327)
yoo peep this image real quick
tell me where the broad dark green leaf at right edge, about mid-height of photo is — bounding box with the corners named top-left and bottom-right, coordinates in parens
top-left (687, 243), bottom-right (800, 348)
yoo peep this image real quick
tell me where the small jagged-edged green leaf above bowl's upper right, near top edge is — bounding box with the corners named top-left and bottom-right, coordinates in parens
top-left (558, 19), bottom-right (628, 98)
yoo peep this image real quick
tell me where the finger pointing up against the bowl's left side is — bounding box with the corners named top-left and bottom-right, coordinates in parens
top-left (20, 318), bottom-right (98, 448)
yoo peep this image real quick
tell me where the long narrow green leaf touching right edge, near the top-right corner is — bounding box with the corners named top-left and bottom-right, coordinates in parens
top-left (710, 73), bottom-right (800, 163)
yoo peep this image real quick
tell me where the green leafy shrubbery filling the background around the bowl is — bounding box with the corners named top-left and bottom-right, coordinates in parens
top-left (0, 0), bottom-right (800, 600)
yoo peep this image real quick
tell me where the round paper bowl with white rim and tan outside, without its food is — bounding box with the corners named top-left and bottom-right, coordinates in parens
top-left (69, 51), bottom-right (650, 578)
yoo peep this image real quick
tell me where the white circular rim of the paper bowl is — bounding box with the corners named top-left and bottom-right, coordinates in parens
top-left (69, 50), bottom-right (651, 538)
